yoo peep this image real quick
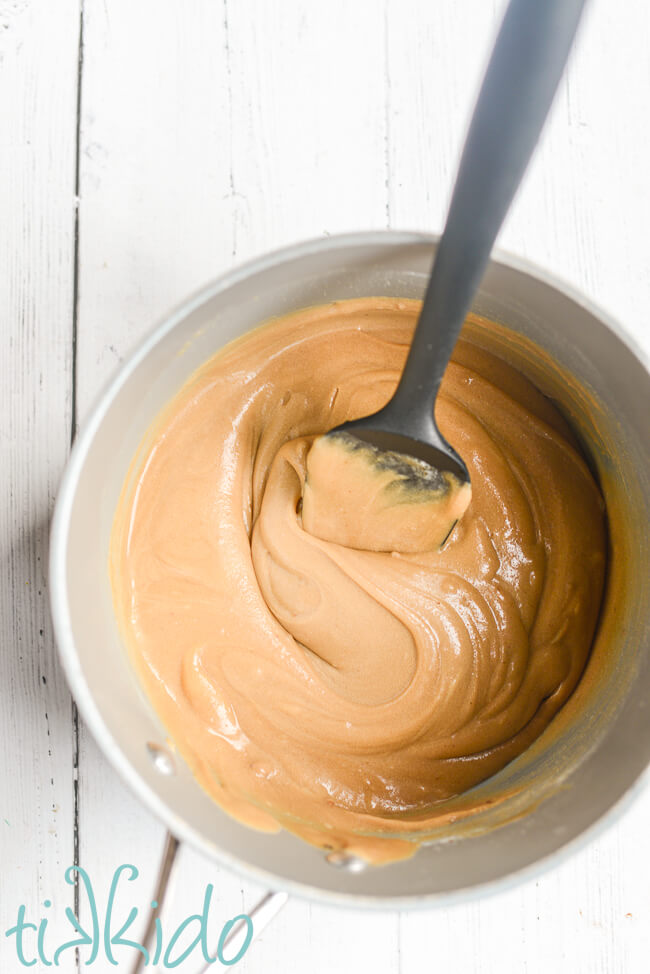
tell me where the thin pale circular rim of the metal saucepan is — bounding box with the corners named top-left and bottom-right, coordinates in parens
top-left (49, 230), bottom-right (650, 910)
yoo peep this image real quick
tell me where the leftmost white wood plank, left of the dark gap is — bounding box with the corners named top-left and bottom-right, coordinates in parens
top-left (0, 0), bottom-right (79, 971)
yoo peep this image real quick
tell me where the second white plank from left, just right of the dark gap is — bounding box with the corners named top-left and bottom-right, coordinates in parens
top-left (71, 0), bottom-right (232, 963)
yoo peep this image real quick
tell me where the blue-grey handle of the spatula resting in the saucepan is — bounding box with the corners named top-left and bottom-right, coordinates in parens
top-left (394, 0), bottom-right (585, 411)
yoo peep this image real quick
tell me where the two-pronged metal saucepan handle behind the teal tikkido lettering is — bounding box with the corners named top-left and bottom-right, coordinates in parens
top-left (131, 832), bottom-right (289, 974)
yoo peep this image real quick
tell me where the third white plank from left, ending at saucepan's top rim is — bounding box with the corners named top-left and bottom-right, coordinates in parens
top-left (220, 0), bottom-right (386, 259)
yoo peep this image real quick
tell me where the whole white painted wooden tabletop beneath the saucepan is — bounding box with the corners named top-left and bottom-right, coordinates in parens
top-left (0, 0), bottom-right (650, 974)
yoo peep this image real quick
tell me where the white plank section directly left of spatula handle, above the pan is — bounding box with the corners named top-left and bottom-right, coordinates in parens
top-left (386, 0), bottom-right (505, 233)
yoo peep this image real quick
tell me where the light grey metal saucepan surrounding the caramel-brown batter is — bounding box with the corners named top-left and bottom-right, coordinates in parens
top-left (50, 231), bottom-right (650, 936)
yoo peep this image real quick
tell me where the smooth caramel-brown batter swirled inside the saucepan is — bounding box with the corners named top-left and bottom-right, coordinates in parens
top-left (111, 298), bottom-right (606, 862)
